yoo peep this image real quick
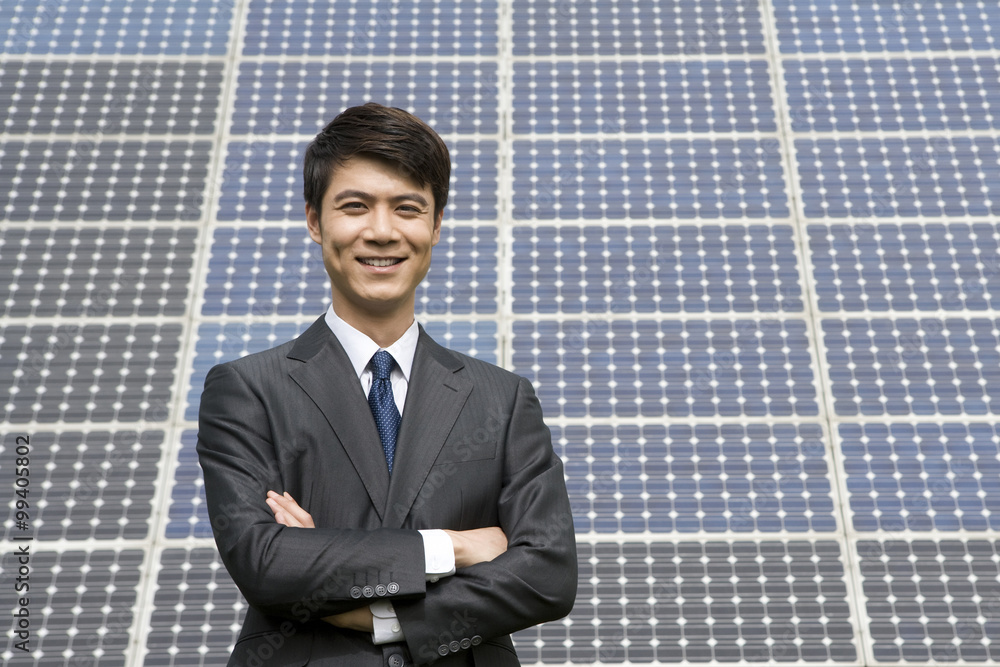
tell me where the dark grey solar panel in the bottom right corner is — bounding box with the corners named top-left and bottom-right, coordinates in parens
top-left (857, 539), bottom-right (1000, 664)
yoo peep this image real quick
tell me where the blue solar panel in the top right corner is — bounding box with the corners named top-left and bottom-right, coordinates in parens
top-left (773, 0), bottom-right (1000, 53)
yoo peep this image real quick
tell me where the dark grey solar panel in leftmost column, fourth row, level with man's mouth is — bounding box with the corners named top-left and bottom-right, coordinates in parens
top-left (0, 225), bottom-right (197, 317)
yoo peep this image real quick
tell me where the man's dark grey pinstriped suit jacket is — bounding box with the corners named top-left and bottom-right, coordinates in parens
top-left (198, 317), bottom-right (577, 667)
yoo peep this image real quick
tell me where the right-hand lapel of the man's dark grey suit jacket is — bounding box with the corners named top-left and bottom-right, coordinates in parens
top-left (382, 327), bottom-right (472, 528)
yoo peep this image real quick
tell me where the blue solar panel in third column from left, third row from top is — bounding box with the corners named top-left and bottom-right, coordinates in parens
top-left (512, 139), bottom-right (788, 220)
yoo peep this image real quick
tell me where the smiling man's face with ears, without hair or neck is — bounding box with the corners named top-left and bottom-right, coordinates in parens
top-left (306, 155), bottom-right (442, 324)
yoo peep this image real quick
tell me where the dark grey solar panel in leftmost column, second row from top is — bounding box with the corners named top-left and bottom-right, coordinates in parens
top-left (0, 61), bottom-right (223, 134)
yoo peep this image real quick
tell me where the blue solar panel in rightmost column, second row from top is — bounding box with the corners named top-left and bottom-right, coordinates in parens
top-left (785, 58), bottom-right (1000, 132)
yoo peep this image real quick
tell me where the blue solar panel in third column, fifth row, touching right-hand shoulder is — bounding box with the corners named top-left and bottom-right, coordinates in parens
top-left (512, 320), bottom-right (818, 417)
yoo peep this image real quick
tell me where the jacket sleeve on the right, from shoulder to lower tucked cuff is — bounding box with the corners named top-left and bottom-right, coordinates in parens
top-left (393, 378), bottom-right (577, 664)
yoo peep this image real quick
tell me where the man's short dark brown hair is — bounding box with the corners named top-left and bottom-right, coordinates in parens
top-left (302, 102), bottom-right (451, 219)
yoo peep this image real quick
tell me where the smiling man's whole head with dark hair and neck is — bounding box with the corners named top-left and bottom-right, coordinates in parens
top-left (304, 104), bottom-right (451, 346)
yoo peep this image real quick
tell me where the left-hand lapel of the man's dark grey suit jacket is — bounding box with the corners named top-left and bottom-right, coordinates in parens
top-left (288, 317), bottom-right (390, 521)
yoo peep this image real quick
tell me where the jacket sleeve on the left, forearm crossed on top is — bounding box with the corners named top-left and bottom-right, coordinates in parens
top-left (197, 364), bottom-right (426, 623)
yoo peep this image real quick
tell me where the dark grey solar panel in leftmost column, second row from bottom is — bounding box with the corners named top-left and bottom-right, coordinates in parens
top-left (0, 429), bottom-right (165, 545)
